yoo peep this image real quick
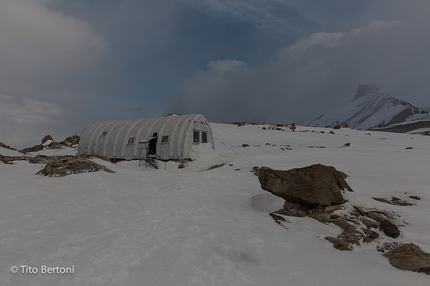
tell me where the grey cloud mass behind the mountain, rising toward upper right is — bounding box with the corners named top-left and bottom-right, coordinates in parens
top-left (170, 1), bottom-right (430, 122)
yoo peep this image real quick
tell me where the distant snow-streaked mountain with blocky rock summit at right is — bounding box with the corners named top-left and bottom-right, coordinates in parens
top-left (307, 84), bottom-right (430, 129)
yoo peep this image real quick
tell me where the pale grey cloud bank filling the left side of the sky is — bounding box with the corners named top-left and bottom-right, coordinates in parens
top-left (0, 0), bottom-right (109, 148)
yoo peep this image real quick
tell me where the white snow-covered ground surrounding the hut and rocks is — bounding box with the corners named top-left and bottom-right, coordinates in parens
top-left (0, 124), bottom-right (430, 286)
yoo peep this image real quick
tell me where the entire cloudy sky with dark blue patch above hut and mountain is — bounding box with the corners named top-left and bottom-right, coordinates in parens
top-left (0, 0), bottom-right (430, 148)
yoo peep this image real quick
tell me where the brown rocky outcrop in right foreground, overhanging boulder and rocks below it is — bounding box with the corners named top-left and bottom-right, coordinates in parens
top-left (253, 164), bottom-right (430, 275)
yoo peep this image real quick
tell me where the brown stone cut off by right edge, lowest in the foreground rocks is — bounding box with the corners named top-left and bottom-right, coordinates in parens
top-left (384, 243), bottom-right (430, 275)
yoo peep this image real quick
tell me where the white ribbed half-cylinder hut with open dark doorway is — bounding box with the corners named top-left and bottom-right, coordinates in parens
top-left (78, 114), bottom-right (214, 161)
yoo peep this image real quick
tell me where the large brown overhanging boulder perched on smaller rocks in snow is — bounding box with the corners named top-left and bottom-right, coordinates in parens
top-left (258, 164), bottom-right (352, 207)
